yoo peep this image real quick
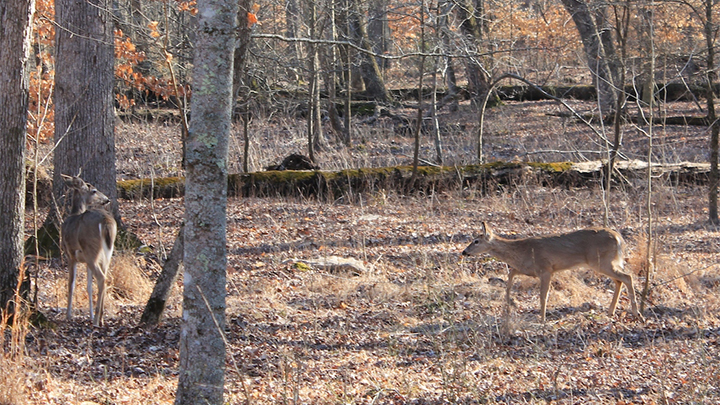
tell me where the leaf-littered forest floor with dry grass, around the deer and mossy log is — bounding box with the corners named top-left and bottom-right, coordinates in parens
top-left (7, 98), bottom-right (720, 405)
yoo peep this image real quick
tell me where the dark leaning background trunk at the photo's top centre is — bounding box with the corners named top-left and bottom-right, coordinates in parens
top-left (349, 0), bottom-right (390, 101)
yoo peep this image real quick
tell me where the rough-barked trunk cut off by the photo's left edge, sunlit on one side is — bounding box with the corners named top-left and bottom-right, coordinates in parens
top-left (0, 0), bottom-right (35, 316)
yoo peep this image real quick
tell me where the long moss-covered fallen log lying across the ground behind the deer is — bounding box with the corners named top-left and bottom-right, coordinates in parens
top-left (118, 161), bottom-right (710, 201)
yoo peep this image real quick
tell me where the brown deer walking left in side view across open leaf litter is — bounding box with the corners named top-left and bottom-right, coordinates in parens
top-left (462, 222), bottom-right (643, 323)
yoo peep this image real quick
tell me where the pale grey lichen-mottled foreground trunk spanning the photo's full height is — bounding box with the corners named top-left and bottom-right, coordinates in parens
top-left (175, 0), bottom-right (238, 405)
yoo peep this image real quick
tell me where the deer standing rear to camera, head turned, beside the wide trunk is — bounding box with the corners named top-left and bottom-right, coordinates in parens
top-left (60, 174), bottom-right (117, 327)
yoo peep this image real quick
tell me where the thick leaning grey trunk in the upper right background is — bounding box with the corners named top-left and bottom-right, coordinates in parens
top-left (562, 0), bottom-right (618, 115)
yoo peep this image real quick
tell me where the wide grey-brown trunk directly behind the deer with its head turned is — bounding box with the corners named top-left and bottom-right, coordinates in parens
top-left (51, 0), bottom-right (120, 218)
